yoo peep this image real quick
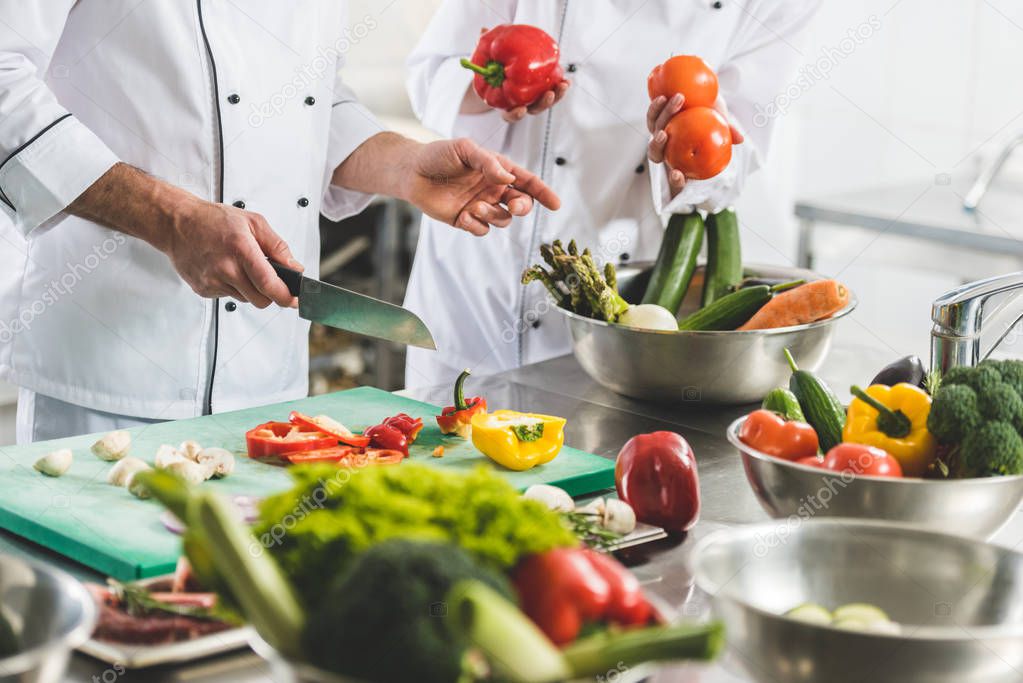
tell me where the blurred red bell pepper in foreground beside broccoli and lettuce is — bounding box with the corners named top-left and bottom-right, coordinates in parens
top-left (513, 548), bottom-right (652, 645)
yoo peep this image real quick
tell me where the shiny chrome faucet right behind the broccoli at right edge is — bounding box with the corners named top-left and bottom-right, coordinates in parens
top-left (931, 272), bottom-right (1023, 372)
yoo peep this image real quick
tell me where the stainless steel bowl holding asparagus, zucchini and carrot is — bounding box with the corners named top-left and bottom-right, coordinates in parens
top-left (558, 259), bottom-right (856, 404)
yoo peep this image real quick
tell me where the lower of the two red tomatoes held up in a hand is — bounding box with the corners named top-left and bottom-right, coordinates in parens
top-left (664, 106), bottom-right (731, 180)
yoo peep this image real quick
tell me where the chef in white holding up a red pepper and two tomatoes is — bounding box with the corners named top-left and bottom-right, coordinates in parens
top-left (405, 0), bottom-right (817, 386)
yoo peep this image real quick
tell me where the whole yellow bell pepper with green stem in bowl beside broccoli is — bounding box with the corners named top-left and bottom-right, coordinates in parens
top-left (842, 382), bottom-right (937, 476)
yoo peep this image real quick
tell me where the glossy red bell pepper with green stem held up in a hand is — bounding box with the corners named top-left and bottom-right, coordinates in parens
top-left (461, 24), bottom-right (565, 110)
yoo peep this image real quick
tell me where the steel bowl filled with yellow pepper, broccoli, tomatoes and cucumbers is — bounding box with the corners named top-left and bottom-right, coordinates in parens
top-left (726, 359), bottom-right (1023, 539)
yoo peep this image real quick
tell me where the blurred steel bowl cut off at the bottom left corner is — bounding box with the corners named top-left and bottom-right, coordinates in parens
top-left (0, 555), bottom-right (96, 683)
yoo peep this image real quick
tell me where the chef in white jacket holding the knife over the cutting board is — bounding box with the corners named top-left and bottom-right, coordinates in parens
top-left (0, 0), bottom-right (558, 442)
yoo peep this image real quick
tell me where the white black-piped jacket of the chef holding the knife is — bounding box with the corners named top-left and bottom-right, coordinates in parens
top-left (0, 0), bottom-right (381, 418)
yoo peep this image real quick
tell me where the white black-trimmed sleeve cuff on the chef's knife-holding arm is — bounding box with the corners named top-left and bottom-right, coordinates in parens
top-left (0, 113), bottom-right (120, 237)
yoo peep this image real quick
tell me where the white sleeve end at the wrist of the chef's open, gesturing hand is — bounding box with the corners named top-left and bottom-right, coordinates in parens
top-left (320, 98), bottom-right (385, 221)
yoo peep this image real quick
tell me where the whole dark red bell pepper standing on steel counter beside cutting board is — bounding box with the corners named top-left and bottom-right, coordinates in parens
top-left (615, 431), bottom-right (700, 532)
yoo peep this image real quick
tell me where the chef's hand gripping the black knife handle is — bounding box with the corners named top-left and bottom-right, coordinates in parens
top-left (163, 199), bottom-right (302, 309)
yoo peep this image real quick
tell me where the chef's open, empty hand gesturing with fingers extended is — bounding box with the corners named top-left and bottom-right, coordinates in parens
top-left (405, 138), bottom-right (561, 235)
